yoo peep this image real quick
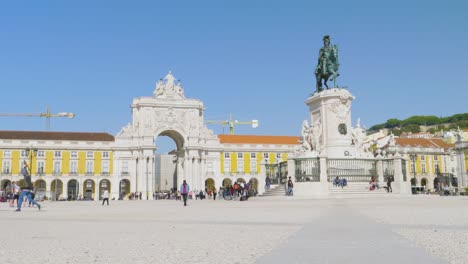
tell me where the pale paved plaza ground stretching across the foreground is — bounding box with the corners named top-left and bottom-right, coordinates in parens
top-left (0, 195), bottom-right (468, 264)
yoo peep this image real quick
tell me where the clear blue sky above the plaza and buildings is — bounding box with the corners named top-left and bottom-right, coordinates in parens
top-left (0, 0), bottom-right (468, 147)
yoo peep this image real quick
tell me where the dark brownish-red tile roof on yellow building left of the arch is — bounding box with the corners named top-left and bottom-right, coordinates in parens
top-left (0, 130), bottom-right (115, 141)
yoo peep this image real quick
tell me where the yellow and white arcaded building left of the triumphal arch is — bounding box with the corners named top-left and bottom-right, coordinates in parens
top-left (0, 131), bottom-right (114, 199)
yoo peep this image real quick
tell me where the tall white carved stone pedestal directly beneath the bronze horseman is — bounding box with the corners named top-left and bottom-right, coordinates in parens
top-left (305, 88), bottom-right (356, 158)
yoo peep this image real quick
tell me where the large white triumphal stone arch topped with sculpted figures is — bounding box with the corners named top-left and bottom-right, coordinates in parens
top-left (115, 72), bottom-right (219, 196)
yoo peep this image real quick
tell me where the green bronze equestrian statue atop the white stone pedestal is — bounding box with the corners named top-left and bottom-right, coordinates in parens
top-left (315, 35), bottom-right (340, 92)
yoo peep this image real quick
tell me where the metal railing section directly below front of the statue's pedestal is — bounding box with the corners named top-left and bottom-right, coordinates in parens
top-left (327, 159), bottom-right (377, 182)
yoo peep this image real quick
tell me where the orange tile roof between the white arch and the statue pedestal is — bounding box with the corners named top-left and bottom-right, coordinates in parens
top-left (218, 135), bottom-right (299, 145)
